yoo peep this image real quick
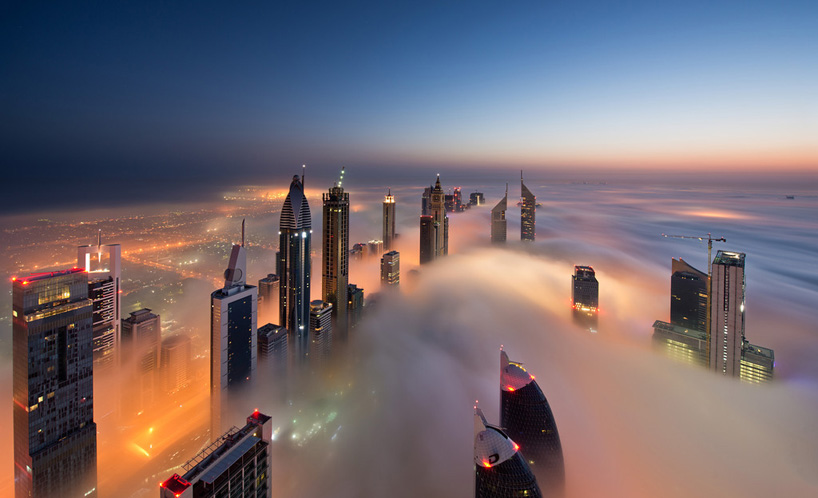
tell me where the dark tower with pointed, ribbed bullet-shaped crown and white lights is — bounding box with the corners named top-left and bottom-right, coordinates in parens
top-left (278, 176), bottom-right (312, 361)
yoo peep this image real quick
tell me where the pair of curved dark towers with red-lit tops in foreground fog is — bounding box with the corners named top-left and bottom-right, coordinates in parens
top-left (474, 350), bottom-right (565, 498)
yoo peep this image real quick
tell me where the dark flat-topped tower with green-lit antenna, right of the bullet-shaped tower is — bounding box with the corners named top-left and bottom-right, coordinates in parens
top-left (318, 178), bottom-right (349, 340)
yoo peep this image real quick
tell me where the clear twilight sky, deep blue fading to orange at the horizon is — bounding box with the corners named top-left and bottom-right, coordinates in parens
top-left (0, 1), bottom-right (818, 200)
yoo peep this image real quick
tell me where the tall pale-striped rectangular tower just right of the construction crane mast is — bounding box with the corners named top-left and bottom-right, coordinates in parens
top-left (710, 251), bottom-right (744, 377)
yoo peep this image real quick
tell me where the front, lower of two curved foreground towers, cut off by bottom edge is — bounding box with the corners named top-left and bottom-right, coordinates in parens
top-left (474, 407), bottom-right (542, 498)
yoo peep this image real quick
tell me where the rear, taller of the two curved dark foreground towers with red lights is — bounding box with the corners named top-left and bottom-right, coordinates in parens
top-left (500, 351), bottom-right (565, 495)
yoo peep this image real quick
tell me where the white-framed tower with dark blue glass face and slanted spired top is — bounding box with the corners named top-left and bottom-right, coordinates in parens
top-left (210, 222), bottom-right (258, 437)
